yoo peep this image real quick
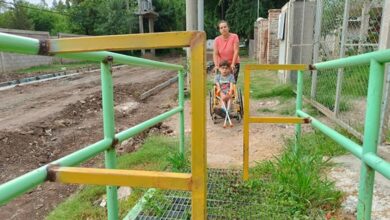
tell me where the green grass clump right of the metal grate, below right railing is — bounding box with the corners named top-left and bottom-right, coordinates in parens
top-left (247, 131), bottom-right (346, 219)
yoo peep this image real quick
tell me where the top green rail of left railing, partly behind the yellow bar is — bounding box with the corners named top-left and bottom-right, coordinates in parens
top-left (0, 33), bottom-right (184, 70)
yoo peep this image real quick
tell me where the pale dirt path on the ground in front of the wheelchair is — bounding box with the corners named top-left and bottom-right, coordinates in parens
top-left (166, 100), bottom-right (294, 168)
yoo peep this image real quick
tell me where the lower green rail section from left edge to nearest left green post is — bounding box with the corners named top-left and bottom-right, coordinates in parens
top-left (0, 139), bottom-right (112, 206)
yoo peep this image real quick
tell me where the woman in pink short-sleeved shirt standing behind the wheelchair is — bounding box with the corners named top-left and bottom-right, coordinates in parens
top-left (213, 20), bottom-right (240, 82)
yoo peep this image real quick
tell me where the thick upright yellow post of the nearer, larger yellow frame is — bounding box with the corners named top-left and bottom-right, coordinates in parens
top-left (190, 32), bottom-right (207, 220)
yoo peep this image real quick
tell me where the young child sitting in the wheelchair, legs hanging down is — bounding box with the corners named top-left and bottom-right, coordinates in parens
top-left (214, 60), bottom-right (235, 127)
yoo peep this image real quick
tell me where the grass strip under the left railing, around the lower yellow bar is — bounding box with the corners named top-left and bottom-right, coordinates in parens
top-left (46, 136), bottom-right (187, 220)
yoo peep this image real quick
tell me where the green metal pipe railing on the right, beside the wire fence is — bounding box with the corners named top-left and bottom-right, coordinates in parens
top-left (296, 50), bottom-right (390, 219)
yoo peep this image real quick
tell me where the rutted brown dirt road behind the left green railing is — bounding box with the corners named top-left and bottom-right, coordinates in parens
top-left (0, 60), bottom-right (177, 219)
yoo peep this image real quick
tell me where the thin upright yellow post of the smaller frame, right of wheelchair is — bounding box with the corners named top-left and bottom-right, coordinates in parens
top-left (243, 68), bottom-right (251, 180)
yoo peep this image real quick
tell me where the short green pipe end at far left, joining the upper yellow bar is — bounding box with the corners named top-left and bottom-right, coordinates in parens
top-left (0, 33), bottom-right (39, 54)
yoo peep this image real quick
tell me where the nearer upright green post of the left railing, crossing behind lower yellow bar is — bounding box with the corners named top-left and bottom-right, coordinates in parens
top-left (100, 57), bottom-right (118, 220)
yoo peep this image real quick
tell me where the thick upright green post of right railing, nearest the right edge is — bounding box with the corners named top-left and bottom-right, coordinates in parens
top-left (358, 59), bottom-right (384, 220)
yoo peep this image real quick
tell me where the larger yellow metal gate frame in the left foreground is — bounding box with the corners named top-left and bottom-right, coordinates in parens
top-left (49, 31), bottom-right (207, 219)
